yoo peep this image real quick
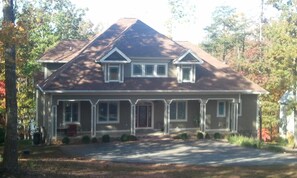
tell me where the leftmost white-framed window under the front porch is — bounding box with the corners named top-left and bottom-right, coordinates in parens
top-left (63, 101), bottom-right (80, 123)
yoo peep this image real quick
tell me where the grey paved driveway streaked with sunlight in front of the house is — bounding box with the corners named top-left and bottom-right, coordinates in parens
top-left (61, 140), bottom-right (297, 166)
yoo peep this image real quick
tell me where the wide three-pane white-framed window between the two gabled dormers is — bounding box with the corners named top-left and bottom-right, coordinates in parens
top-left (132, 63), bottom-right (168, 77)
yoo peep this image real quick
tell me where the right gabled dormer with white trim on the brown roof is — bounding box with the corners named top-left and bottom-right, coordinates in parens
top-left (173, 50), bottom-right (203, 83)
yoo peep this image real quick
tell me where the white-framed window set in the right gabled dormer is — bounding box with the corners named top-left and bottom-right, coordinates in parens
top-left (178, 65), bottom-right (195, 83)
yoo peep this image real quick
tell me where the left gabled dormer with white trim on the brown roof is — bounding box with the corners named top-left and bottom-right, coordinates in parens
top-left (96, 47), bottom-right (131, 83)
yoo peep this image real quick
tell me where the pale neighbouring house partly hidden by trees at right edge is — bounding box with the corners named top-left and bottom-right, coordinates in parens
top-left (278, 90), bottom-right (297, 138)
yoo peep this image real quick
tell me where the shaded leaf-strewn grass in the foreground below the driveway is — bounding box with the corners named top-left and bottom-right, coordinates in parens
top-left (0, 140), bottom-right (297, 178)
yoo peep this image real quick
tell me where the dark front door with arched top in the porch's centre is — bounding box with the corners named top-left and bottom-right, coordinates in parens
top-left (136, 102), bottom-right (152, 128)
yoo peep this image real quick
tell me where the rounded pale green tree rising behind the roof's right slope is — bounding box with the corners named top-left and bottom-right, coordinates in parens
top-left (202, 6), bottom-right (250, 62)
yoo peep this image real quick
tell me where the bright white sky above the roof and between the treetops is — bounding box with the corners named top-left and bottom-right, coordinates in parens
top-left (71, 0), bottom-right (266, 44)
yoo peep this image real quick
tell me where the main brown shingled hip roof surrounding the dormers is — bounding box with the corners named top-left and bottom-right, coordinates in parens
top-left (39, 19), bottom-right (266, 93)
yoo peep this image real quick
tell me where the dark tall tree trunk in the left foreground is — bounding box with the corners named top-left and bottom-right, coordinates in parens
top-left (2, 0), bottom-right (18, 173)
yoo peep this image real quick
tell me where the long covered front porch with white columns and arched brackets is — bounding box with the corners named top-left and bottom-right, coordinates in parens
top-left (43, 96), bottom-right (240, 139)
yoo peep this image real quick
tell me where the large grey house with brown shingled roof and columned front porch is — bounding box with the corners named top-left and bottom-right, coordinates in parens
top-left (36, 18), bottom-right (267, 139)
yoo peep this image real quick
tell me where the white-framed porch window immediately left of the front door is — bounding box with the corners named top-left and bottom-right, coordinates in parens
top-left (97, 101), bottom-right (120, 123)
